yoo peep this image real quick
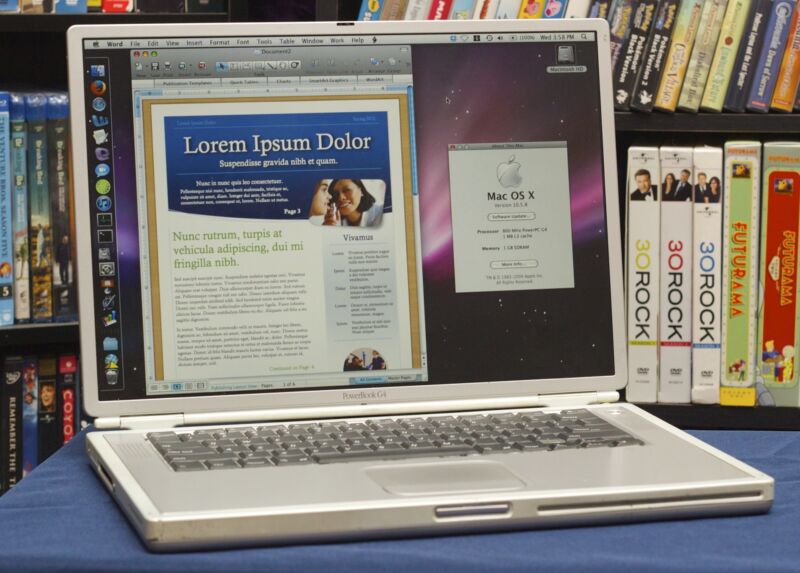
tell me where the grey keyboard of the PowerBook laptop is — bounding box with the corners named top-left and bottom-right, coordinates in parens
top-left (147, 409), bottom-right (643, 471)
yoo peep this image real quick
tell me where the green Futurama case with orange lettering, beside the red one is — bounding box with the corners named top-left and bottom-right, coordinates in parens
top-left (719, 141), bottom-right (761, 406)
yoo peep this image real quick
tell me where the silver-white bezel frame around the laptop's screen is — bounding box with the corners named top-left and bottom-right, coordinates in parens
top-left (67, 19), bottom-right (627, 417)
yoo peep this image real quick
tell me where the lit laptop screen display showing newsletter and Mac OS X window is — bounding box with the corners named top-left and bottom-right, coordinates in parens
top-left (76, 32), bottom-right (615, 400)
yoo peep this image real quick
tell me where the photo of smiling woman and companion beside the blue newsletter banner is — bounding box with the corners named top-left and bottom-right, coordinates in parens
top-left (309, 179), bottom-right (386, 227)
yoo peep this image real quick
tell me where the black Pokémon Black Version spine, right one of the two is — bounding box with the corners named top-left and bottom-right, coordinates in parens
top-left (630, 0), bottom-right (680, 112)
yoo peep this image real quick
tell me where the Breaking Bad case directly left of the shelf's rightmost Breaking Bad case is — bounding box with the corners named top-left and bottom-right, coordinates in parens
top-left (25, 94), bottom-right (53, 322)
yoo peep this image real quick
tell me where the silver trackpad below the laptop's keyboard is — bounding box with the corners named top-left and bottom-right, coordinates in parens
top-left (365, 460), bottom-right (525, 495)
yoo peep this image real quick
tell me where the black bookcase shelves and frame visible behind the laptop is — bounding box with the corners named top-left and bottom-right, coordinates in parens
top-left (0, 0), bottom-right (800, 430)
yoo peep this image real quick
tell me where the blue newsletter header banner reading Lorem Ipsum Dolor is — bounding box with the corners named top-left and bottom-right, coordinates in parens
top-left (164, 112), bottom-right (391, 219)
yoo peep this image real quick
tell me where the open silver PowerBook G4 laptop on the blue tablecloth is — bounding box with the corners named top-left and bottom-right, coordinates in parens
top-left (68, 20), bottom-right (773, 550)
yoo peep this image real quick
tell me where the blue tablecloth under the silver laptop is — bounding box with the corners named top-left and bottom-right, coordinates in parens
top-left (0, 431), bottom-right (800, 573)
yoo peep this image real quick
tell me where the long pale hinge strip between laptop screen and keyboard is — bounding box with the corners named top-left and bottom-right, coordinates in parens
top-left (95, 391), bottom-right (619, 430)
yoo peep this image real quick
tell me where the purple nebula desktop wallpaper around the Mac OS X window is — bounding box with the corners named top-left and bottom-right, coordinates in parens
top-left (413, 42), bottom-right (614, 382)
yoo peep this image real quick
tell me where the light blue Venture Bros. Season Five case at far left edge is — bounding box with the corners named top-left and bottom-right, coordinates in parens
top-left (0, 92), bottom-right (14, 326)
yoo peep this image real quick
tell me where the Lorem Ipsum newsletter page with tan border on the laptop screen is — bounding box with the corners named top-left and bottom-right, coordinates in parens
top-left (142, 93), bottom-right (421, 385)
